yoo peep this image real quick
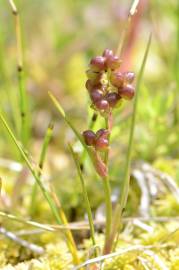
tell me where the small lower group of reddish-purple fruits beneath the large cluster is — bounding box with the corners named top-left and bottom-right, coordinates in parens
top-left (83, 128), bottom-right (109, 151)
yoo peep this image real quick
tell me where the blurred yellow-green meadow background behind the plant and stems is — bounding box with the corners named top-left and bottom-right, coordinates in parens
top-left (0, 0), bottom-right (179, 219)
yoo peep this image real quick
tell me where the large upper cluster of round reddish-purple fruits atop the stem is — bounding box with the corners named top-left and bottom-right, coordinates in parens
top-left (86, 49), bottom-right (135, 115)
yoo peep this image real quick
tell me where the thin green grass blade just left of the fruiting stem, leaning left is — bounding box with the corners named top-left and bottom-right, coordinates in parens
top-left (69, 144), bottom-right (96, 249)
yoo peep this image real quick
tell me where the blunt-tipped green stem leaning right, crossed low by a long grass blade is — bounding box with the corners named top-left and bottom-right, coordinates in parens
top-left (30, 124), bottom-right (53, 216)
